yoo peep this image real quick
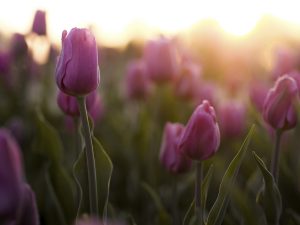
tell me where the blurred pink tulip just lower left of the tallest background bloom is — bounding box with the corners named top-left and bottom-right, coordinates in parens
top-left (125, 60), bottom-right (152, 99)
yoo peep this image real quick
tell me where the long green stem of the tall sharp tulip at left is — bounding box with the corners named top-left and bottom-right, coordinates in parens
top-left (77, 97), bottom-right (99, 216)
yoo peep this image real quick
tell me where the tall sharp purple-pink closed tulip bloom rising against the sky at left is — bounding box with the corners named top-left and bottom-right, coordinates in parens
top-left (55, 28), bottom-right (100, 96)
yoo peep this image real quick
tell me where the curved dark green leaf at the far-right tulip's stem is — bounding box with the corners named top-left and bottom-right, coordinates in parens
top-left (252, 152), bottom-right (282, 224)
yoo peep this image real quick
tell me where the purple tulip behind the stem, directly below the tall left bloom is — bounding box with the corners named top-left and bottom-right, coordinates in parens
top-left (57, 90), bottom-right (98, 116)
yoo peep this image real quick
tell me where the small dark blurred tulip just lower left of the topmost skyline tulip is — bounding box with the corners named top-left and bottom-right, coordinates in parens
top-left (10, 33), bottom-right (28, 59)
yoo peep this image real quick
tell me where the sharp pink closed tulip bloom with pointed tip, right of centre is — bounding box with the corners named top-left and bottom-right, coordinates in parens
top-left (179, 100), bottom-right (220, 161)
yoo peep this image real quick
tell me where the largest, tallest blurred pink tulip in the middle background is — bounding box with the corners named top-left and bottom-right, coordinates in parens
top-left (143, 38), bottom-right (179, 83)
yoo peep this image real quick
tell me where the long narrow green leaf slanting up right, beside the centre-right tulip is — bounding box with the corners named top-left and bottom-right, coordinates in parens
top-left (206, 125), bottom-right (255, 225)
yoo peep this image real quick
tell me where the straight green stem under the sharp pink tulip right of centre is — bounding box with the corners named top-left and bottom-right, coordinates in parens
top-left (195, 161), bottom-right (203, 225)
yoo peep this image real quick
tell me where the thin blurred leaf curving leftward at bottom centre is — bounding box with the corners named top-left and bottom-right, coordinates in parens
top-left (141, 182), bottom-right (171, 225)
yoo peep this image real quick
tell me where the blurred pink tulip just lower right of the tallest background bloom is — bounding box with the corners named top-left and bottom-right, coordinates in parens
top-left (175, 60), bottom-right (201, 99)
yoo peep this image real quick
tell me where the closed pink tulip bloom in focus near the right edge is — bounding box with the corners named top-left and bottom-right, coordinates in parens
top-left (263, 75), bottom-right (298, 130)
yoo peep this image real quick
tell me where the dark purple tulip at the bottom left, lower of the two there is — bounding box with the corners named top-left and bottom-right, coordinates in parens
top-left (17, 183), bottom-right (39, 225)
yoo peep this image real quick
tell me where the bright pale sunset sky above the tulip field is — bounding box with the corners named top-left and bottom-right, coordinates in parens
top-left (0, 0), bottom-right (300, 45)
